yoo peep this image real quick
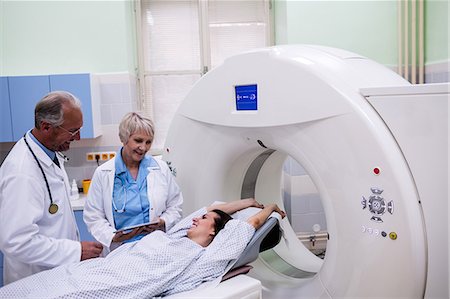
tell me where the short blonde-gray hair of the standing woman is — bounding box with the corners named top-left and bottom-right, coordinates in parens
top-left (119, 112), bottom-right (155, 143)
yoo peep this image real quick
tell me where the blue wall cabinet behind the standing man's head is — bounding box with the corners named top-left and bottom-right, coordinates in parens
top-left (0, 74), bottom-right (101, 142)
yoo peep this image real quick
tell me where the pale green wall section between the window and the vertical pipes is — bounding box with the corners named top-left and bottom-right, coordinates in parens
top-left (274, 0), bottom-right (397, 65)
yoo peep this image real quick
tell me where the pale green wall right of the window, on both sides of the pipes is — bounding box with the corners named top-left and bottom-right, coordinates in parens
top-left (274, 0), bottom-right (450, 66)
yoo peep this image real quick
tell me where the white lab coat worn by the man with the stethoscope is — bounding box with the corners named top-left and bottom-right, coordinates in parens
top-left (0, 132), bottom-right (81, 284)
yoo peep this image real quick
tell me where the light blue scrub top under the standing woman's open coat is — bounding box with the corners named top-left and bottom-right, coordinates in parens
top-left (112, 148), bottom-right (156, 242)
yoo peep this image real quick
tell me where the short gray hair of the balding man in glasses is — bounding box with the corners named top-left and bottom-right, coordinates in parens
top-left (34, 91), bottom-right (81, 129)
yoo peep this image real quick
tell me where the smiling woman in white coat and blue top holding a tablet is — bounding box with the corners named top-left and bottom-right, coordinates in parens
top-left (83, 112), bottom-right (183, 255)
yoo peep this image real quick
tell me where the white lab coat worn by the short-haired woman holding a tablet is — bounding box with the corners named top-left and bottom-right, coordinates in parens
top-left (83, 158), bottom-right (183, 255)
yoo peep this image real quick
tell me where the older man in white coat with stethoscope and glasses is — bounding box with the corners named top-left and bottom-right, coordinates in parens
top-left (0, 91), bottom-right (102, 284)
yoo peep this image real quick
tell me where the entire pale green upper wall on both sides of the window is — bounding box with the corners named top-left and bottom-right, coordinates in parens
top-left (0, 0), bottom-right (450, 76)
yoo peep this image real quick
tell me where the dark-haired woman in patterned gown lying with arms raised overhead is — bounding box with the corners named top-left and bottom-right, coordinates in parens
top-left (0, 198), bottom-right (285, 298)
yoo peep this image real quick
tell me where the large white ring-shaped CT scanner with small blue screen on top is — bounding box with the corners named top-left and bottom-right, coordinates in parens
top-left (163, 45), bottom-right (449, 298)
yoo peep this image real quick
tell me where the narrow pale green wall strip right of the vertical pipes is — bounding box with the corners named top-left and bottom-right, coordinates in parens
top-left (425, 0), bottom-right (450, 63)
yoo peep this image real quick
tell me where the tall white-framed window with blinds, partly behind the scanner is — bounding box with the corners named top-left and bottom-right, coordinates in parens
top-left (139, 0), bottom-right (272, 150)
